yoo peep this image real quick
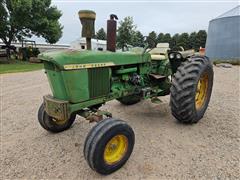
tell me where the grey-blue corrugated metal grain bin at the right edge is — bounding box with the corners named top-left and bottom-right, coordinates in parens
top-left (206, 6), bottom-right (240, 60)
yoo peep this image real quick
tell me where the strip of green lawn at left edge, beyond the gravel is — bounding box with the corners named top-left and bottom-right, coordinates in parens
top-left (0, 58), bottom-right (43, 74)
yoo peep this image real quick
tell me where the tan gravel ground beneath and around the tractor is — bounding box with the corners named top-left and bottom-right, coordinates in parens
top-left (0, 67), bottom-right (240, 179)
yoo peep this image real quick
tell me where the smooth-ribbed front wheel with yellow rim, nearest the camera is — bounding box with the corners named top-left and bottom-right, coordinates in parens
top-left (84, 118), bottom-right (135, 174)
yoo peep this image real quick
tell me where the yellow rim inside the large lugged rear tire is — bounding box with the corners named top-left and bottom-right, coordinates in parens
top-left (195, 73), bottom-right (208, 110)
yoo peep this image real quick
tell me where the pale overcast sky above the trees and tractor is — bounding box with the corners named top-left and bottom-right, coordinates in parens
top-left (33, 0), bottom-right (239, 44)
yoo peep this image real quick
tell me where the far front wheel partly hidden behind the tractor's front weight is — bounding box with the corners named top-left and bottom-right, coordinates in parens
top-left (38, 104), bottom-right (76, 133)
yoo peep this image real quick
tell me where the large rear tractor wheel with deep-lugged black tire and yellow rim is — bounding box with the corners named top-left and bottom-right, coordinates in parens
top-left (170, 56), bottom-right (213, 124)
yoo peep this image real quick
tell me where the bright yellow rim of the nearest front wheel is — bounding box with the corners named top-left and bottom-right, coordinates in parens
top-left (103, 135), bottom-right (128, 165)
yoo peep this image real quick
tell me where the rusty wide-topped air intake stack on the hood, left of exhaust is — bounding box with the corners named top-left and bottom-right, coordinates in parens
top-left (78, 10), bottom-right (96, 50)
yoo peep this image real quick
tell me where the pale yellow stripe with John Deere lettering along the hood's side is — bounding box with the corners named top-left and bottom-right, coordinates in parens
top-left (63, 62), bottom-right (115, 70)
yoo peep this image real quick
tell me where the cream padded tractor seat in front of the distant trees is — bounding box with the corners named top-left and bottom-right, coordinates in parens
top-left (149, 43), bottom-right (169, 60)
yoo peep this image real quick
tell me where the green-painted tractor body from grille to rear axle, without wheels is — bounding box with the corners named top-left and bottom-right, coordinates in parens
top-left (39, 50), bottom-right (177, 121)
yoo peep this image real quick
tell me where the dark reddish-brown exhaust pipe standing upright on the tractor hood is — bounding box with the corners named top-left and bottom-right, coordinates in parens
top-left (107, 14), bottom-right (118, 52)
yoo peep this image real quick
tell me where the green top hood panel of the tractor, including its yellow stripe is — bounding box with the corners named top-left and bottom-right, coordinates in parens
top-left (38, 49), bottom-right (151, 70)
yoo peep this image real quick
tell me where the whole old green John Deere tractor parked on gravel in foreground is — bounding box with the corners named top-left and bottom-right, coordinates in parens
top-left (38, 10), bottom-right (213, 174)
